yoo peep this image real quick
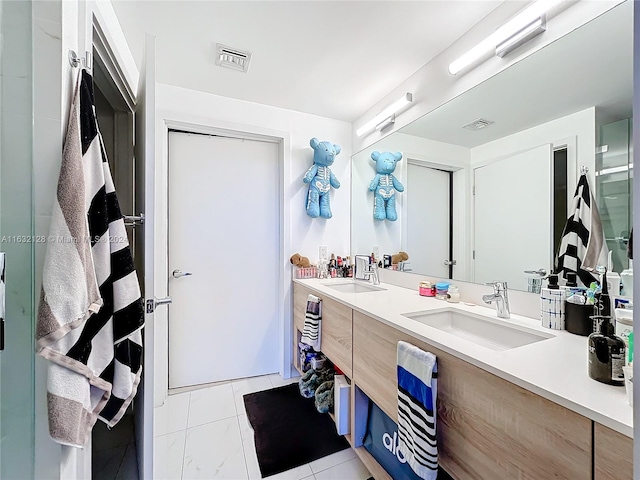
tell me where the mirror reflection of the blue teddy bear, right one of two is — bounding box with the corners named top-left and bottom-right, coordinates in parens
top-left (369, 151), bottom-right (404, 222)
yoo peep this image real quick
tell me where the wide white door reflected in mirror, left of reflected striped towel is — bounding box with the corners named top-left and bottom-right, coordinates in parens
top-left (474, 144), bottom-right (553, 290)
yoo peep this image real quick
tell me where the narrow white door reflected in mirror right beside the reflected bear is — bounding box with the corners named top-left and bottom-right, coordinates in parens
top-left (405, 163), bottom-right (451, 278)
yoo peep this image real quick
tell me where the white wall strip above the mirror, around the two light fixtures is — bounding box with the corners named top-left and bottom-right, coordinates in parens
top-left (353, 0), bottom-right (624, 152)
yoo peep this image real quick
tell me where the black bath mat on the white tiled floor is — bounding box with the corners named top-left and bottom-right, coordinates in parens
top-left (244, 383), bottom-right (349, 478)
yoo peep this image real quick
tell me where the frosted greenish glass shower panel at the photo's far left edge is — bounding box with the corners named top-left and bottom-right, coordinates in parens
top-left (0, 0), bottom-right (35, 479)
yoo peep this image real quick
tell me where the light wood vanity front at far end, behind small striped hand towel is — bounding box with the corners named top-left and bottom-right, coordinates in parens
top-left (293, 283), bottom-right (352, 378)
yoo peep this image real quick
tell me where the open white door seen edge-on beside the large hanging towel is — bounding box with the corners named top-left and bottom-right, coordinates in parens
top-left (134, 35), bottom-right (156, 478)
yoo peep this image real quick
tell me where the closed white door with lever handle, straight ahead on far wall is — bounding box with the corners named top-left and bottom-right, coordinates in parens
top-left (169, 132), bottom-right (280, 388)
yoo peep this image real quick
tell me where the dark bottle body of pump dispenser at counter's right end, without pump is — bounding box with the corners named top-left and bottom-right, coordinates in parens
top-left (589, 315), bottom-right (626, 386)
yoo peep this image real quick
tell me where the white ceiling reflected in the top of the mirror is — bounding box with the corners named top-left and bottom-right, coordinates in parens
top-left (401, 2), bottom-right (633, 148)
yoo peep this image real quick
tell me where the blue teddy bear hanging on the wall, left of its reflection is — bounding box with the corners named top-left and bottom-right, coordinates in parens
top-left (302, 137), bottom-right (340, 218)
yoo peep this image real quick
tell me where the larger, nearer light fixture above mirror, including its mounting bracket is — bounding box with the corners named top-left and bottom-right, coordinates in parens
top-left (449, 0), bottom-right (563, 75)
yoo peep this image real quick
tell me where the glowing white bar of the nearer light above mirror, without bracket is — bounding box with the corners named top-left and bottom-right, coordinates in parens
top-left (449, 0), bottom-right (563, 75)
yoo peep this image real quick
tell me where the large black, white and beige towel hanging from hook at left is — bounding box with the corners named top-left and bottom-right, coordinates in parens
top-left (36, 70), bottom-right (144, 446)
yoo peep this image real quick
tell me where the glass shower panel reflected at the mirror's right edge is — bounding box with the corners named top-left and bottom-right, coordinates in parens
top-left (596, 119), bottom-right (633, 272)
